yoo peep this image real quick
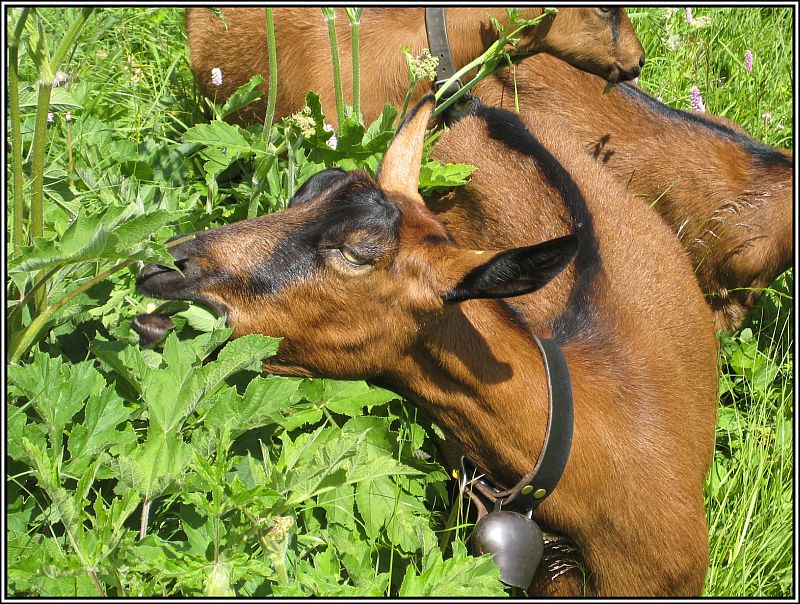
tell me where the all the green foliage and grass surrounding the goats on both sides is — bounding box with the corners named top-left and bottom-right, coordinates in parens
top-left (6, 7), bottom-right (794, 598)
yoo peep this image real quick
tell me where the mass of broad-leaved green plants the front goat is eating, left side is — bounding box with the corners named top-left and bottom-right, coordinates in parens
top-left (6, 9), bottom-right (506, 597)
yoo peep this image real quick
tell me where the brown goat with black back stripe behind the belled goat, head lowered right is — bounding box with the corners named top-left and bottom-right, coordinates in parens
top-left (476, 55), bottom-right (794, 330)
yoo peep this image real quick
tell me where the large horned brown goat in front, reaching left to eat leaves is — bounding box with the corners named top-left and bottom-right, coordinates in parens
top-left (138, 97), bottom-right (716, 596)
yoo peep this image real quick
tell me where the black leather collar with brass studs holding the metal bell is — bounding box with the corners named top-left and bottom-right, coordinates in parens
top-left (461, 334), bottom-right (574, 517)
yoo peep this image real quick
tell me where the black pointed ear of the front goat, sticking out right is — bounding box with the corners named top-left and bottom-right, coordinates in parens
top-left (444, 235), bottom-right (578, 302)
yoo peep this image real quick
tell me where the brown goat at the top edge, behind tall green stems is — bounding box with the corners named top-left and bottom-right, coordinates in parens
top-left (185, 7), bottom-right (644, 123)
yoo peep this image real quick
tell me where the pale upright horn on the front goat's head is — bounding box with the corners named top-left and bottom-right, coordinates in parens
top-left (378, 94), bottom-right (434, 197)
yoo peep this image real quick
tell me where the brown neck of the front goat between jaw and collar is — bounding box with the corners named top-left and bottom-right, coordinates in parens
top-left (383, 300), bottom-right (548, 488)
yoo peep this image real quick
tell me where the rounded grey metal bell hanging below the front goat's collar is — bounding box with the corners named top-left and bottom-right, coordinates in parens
top-left (472, 510), bottom-right (544, 589)
